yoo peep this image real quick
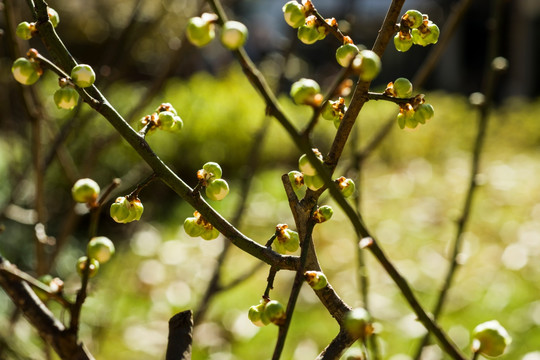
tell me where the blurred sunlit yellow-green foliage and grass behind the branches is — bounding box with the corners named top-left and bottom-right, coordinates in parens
top-left (0, 62), bottom-right (540, 359)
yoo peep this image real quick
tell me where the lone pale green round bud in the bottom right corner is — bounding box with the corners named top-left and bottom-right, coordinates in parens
top-left (472, 320), bottom-right (512, 357)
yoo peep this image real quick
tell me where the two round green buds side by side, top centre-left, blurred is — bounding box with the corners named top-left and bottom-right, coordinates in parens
top-left (186, 13), bottom-right (248, 50)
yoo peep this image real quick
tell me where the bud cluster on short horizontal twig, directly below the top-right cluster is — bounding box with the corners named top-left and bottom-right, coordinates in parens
top-left (384, 78), bottom-right (435, 129)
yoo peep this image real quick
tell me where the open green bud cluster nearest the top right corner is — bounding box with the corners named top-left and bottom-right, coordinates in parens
top-left (394, 10), bottom-right (440, 52)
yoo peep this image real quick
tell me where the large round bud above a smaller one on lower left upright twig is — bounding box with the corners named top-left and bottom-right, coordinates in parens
top-left (77, 236), bottom-right (115, 278)
